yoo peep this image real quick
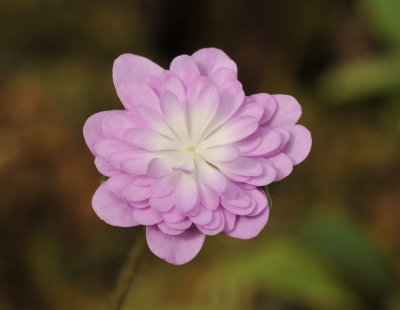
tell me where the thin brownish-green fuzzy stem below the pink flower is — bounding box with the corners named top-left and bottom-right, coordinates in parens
top-left (105, 227), bottom-right (146, 310)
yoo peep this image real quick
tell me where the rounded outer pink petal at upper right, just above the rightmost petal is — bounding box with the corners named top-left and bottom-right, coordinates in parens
top-left (267, 95), bottom-right (301, 127)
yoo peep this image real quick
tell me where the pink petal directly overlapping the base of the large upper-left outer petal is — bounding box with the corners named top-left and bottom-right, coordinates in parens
top-left (117, 81), bottom-right (160, 111)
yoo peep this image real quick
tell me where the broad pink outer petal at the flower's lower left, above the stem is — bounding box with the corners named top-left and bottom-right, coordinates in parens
top-left (92, 182), bottom-right (138, 227)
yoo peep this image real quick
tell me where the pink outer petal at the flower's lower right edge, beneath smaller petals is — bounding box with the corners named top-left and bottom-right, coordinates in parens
top-left (226, 208), bottom-right (269, 239)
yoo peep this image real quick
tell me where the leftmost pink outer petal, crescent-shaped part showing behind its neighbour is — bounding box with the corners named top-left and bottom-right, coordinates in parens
top-left (83, 111), bottom-right (113, 155)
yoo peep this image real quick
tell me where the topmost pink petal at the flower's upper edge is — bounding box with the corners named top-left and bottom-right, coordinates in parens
top-left (192, 47), bottom-right (237, 76)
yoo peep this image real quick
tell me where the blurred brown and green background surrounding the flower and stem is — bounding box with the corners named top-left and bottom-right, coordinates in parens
top-left (0, 0), bottom-right (400, 310)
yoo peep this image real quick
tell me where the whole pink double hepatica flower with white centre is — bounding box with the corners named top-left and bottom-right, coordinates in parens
top-left (83, 48), bottom-right (311, 265)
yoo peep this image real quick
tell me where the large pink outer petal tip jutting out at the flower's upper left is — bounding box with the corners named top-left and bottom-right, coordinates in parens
top-left (113, 54), bottom-right (164, 88)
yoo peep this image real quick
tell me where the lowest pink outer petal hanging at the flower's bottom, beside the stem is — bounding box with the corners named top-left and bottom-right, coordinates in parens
top-left (146, 226), bottom-right (205, 265)
